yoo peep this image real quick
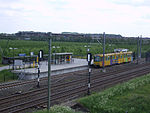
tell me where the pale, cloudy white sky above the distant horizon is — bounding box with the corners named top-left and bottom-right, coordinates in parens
top-left (0, 0), bottom-right (150, 37)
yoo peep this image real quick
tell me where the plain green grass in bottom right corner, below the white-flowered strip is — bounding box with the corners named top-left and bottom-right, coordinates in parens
top-left (108, 84), bottom-right (150, 113)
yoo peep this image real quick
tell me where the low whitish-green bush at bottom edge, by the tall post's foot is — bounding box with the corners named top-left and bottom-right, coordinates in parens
top-left (35, 105), bottom-right (80, 113)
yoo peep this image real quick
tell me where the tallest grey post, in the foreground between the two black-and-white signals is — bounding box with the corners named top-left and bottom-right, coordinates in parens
top-left (47, 39), bottom-right (51, 111)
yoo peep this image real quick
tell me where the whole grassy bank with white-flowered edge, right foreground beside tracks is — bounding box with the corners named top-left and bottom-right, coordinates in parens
top-left (79, 74), bottom-right (150, 113)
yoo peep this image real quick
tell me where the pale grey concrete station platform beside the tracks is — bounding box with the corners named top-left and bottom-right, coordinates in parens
top-left (13, 58), bottom-right (88, 80)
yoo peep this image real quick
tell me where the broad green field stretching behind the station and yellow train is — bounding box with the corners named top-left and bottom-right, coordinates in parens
top-left (0, 40), bottom-right (149, 65)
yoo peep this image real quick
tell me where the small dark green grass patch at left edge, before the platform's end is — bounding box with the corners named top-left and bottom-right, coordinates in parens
top-left (0, 70), bottom-right (17, 82)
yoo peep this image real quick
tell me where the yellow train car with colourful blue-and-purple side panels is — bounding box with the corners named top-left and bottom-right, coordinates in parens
top-left (94, 51), bottom-right (133, 67)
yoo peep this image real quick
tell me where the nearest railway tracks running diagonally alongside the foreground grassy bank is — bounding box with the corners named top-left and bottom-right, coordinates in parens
top-left (0, 64), bottom-right (150, 113)
